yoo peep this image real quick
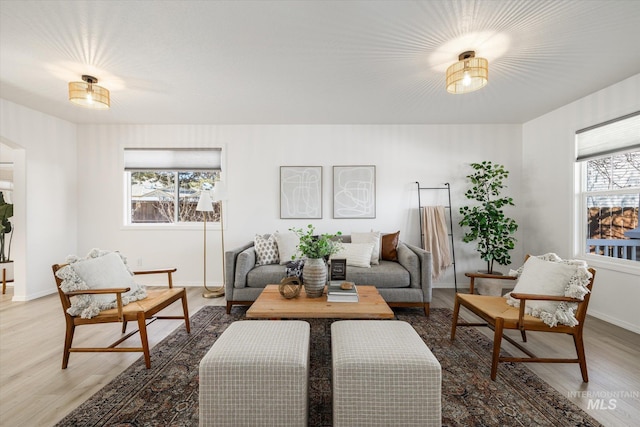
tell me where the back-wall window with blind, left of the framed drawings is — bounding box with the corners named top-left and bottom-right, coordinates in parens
top-left (124, 148), bottom-right (221, 225)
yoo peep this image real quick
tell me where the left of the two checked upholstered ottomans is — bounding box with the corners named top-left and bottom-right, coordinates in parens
top-left (199, 320), bottom-right (310, 427)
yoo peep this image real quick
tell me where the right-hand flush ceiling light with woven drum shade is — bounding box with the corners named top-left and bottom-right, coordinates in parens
top-left (447, 50), bottom-right (489, 94)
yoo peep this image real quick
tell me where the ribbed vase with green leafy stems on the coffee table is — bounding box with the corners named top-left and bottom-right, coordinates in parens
top-left (289, 224), bottom-right (342, 298)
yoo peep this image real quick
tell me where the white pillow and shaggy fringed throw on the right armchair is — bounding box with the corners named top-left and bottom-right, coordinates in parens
top-left (506, 254), bottom-right (591, 326)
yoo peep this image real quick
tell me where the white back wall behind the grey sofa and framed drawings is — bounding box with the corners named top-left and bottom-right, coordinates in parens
top-left (78, 125), bottom-right (523, 286)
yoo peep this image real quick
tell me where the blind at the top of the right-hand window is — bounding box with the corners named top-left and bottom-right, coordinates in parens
top-left (576, 111), bottom-right (640, 162)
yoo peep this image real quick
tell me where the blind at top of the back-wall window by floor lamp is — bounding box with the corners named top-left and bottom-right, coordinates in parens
top-left (124, 148), bottom-right (222, 171)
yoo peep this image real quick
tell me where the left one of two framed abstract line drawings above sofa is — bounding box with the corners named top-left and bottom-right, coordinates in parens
top-left (280, 166), bottom-right (322, 219)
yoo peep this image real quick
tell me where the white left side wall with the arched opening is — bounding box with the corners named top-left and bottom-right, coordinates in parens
top-left (0, 99), bottom-right (77, 301)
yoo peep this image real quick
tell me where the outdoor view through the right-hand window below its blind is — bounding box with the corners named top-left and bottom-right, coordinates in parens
top-left (583, 151), bottom-right (640, 261)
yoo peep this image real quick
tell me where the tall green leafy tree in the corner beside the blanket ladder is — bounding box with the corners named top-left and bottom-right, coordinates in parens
top-left (460, 161), bottom-right (518, 274)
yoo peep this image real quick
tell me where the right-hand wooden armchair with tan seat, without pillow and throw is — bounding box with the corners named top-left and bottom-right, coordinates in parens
top-left (451, 260), bottom-right (596, 382)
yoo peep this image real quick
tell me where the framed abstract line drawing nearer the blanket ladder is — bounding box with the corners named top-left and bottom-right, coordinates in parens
top-left (333, 166), bottom-right (376, 218)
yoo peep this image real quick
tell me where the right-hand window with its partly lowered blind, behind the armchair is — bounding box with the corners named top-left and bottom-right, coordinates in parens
top-left (576, 112), bottom-right (640, 265)
